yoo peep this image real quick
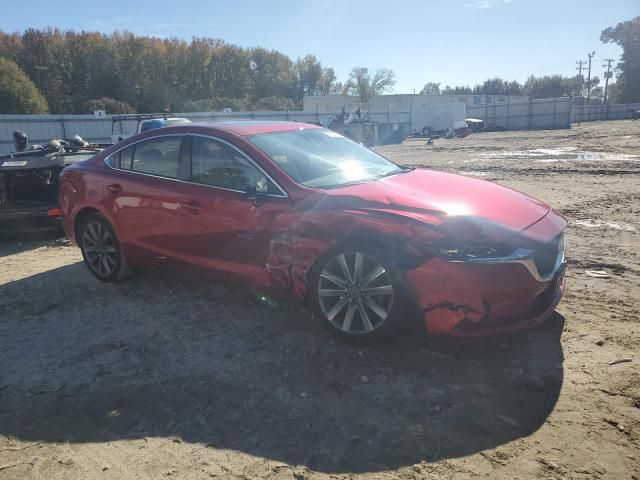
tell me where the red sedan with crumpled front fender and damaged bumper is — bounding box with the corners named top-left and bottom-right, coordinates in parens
top-left (60, 121), bottom-right (567, 341)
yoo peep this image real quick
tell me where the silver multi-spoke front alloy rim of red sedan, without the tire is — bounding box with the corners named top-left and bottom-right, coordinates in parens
top-left (318, 252), bottom-right (394, 335)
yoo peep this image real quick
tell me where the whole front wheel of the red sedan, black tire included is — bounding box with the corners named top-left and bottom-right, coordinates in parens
top-left (310, 247), bottom-right (405, 343)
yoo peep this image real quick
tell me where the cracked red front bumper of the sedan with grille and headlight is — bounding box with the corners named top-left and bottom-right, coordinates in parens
top-left (406, 224), bottom-right (566, 337)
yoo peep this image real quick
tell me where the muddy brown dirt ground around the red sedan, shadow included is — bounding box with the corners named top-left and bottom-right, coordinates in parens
top-left (0, 121), bottom-right (640, 480)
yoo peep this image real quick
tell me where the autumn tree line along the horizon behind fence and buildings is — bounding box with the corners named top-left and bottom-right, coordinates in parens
top-left (0, 17), bottom-right (640, 113)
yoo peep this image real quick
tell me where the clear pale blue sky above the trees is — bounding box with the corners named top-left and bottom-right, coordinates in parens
top-left (0, 0), bottom-right (640, 93)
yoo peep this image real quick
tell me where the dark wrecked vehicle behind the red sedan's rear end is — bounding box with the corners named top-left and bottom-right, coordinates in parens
top-left (0, 136), bottom-right (105, 235)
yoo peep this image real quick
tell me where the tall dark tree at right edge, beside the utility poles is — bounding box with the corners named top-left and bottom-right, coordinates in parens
top-left (600, 17), bottom-right (640, 103)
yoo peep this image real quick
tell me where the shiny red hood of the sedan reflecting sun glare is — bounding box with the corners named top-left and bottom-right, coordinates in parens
top-left (326, 169), bottom-right (551, 242)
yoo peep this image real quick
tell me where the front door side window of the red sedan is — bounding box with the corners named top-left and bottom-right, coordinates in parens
top-left (191, 137), bottom-right (279, 194)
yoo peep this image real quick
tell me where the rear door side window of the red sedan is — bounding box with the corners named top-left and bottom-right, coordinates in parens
top-left (129, 137), bottom-right (182, 178)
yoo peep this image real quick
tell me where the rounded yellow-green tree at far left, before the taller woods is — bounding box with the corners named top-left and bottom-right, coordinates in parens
top-left (0, 58), bottom-right (49, 114)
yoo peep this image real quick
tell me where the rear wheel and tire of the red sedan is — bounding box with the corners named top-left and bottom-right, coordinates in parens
top-left (79, 213), bottom-right (132, 283)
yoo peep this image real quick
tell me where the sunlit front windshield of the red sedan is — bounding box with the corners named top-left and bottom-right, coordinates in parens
top-left (249, 128), bottom-right (402, 188)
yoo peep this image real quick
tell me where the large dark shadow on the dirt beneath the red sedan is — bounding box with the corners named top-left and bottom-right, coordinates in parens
top-left (0, 263), bottom-right (564, 472)
